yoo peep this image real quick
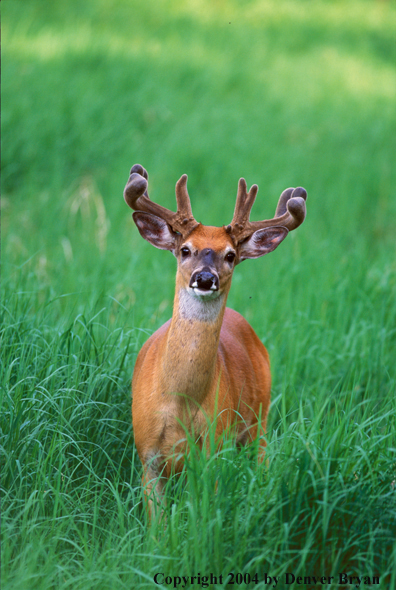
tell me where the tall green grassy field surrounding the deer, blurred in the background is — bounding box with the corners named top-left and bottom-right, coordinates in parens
top-left (0, 0), bottom-right (396, 590)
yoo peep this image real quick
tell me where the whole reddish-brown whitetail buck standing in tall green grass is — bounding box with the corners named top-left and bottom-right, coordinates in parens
top-left (124, 164), bottom-right (307, 512)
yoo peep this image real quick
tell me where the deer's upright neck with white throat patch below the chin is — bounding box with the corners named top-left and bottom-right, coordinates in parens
top-left (163, 282), bottom-right (227, 404)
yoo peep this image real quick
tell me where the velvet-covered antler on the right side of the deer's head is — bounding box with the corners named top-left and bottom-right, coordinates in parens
top-left (226, 178), bottom-right (307, 242)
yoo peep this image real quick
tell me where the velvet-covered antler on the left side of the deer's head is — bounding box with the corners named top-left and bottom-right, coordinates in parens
top-left (124, 164), bottom-right (199, 238)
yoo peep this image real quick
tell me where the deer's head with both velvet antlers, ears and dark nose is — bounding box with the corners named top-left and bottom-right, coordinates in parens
top-left (124, 164), bottom-right (307, 300)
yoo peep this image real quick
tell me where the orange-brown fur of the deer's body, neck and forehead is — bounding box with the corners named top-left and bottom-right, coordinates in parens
top-left (132, 225), bottom-right (271, 512)
